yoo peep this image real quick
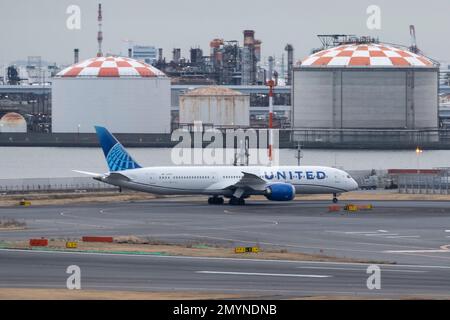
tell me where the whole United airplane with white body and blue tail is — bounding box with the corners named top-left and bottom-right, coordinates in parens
top-left (74, 126), bottom-right (358, 205)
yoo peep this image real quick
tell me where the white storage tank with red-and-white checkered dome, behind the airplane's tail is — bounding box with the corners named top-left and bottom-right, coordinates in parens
top-left (52, 57), bottom-right (170, 133)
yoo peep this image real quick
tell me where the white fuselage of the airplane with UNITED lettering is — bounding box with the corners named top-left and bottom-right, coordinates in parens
top-left (98, 166), bottom-right (358, 197)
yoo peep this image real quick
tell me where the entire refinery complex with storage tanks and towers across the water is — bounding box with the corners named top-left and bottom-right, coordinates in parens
top-left (0, 5), bottom-right (450, 147)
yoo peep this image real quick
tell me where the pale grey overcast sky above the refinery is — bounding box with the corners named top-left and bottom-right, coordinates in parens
top-left (0, 0), bottom-right (450, 64)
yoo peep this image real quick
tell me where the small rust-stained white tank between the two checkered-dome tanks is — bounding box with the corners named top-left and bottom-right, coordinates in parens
top-left (180, 86), bottom-right (250, 127)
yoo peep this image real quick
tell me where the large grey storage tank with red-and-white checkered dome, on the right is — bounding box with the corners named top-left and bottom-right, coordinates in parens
top-left (292, 43), bottom-right (438, 129)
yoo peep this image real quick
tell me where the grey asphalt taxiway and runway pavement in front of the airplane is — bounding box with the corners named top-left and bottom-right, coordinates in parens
top-left (0, 199), bottom-right (450, 297)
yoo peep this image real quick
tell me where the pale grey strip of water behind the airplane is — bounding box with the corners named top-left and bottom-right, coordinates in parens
top-left (0, 147), bottom-right (450, 179)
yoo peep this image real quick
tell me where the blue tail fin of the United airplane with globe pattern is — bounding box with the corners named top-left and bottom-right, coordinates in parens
top-left (95, 126), bottom-right (142, 172)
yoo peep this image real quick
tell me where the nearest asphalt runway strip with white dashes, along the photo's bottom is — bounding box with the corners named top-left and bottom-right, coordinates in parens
top-left (0, 250), bottom-right (450, 299)
